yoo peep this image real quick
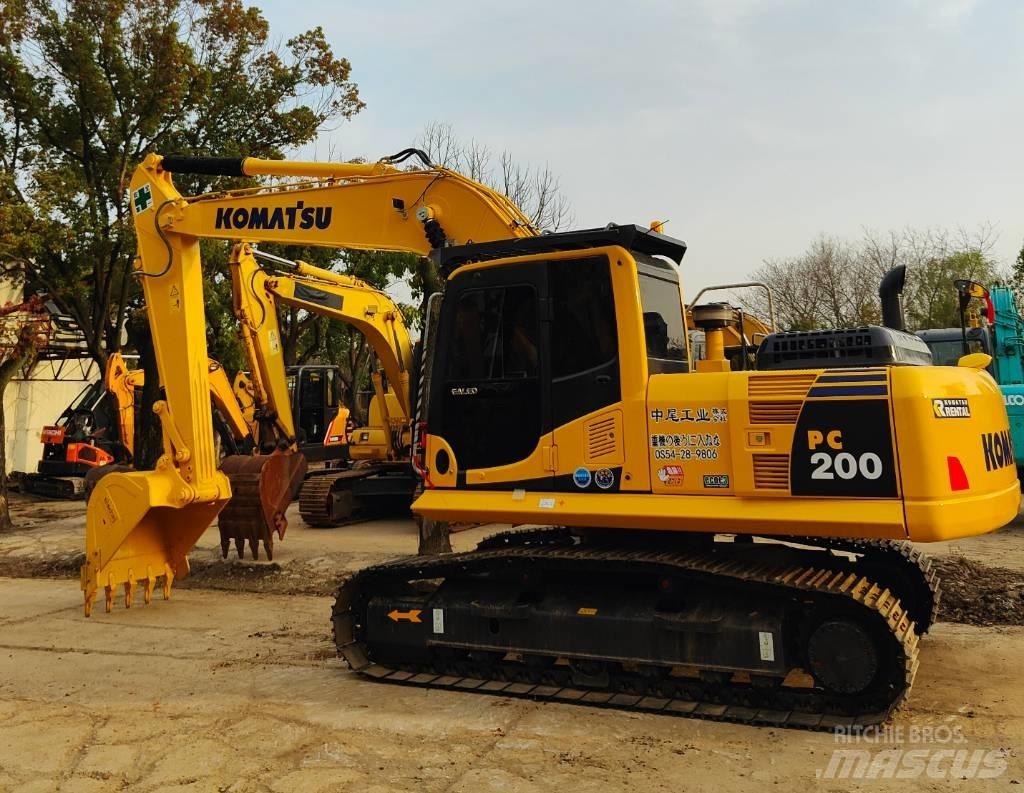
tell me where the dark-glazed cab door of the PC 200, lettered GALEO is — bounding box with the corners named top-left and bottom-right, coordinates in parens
top-left (429, 262), bottom-right (551, 490)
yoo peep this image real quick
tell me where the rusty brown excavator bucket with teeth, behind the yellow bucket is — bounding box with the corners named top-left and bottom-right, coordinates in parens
top-left (217, 451), bottom-right (306, 559)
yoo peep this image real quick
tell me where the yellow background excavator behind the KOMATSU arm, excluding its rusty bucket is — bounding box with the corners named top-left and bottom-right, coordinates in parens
top-left (230, 245), bottom-right (417, 527)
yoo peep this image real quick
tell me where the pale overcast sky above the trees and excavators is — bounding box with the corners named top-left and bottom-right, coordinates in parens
top-left (258, 0), bottom-right (1024, 294)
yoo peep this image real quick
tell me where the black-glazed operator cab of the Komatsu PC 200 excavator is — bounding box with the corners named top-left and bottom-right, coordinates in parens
top-left (428, 225), bottom-right (690, 489)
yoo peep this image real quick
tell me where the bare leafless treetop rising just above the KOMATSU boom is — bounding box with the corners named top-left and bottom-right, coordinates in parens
top-left (416, 121), bottom-right (573, 232)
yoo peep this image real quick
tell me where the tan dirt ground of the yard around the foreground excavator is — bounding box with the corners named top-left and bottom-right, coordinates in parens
top-left (0, 500), bottom-right (1024, 793)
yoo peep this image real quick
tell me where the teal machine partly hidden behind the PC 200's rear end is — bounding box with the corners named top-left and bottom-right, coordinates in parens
top-left (918, 281), bottom-right (1024, 478)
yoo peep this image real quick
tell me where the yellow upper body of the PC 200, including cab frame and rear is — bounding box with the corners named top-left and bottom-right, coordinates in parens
top-left (414, 247), bottom-right (1020, 542)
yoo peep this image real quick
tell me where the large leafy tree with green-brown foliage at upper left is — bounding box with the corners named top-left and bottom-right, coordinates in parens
top-left (0, 0), bottom-right (364, 364)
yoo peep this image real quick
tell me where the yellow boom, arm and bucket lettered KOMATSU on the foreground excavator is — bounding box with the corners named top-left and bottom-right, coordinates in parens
top-left (81, 150), bottom-right (537, 615)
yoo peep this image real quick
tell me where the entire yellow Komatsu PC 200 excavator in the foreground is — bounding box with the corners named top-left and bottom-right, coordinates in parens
top-left (82, 150), bottom-right (1020, 727)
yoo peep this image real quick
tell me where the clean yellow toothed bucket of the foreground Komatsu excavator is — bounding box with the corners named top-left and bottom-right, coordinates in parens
top-left (81, 471), bottom-right (227, 617)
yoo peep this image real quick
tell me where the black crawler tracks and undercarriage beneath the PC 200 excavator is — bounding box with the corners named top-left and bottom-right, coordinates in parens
top-left (333, 529), bottom-right (931, 729)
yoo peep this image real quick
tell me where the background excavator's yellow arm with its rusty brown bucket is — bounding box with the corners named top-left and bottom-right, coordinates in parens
top-left (218, 243), bottom-right (412, 540)
